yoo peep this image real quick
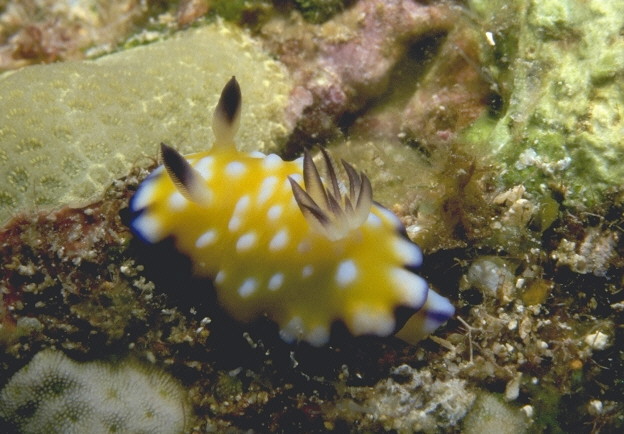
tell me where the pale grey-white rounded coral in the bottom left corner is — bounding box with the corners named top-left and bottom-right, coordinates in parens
top-left (0, 350), bottom-right (190, 434)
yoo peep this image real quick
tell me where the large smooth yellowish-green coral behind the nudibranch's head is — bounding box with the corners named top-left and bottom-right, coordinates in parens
top-left (0, 23), bottom-right (290, 222)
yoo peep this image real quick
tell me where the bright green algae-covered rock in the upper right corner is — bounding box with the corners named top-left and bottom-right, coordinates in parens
top-left (468, 0), bottom-right (624, 206)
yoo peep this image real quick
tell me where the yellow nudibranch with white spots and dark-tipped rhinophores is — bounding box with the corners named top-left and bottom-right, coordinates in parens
top-left (130, 77), bottom-right (454, 346)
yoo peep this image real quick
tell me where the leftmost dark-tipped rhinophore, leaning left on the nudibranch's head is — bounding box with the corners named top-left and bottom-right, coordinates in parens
top-left (160, 143), bottom-right (209, 204)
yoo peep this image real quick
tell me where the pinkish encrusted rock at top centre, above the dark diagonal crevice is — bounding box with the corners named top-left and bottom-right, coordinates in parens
top-left (263, 0), bottom-right (466, 146)
